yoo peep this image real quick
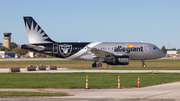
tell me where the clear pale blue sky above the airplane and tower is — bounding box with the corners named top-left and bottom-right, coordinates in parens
top-left (0, 0), bottom-right (180, 49)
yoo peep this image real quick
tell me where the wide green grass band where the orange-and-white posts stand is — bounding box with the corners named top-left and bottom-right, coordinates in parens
top-left (0, 73), bottom-right (180, 88)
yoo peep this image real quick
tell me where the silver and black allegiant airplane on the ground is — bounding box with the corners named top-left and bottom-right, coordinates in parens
top-left (21, 16), bottom-right (165, 67)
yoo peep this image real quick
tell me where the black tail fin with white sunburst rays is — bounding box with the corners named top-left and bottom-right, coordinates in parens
top-left (24, 17), bottom-right (54, 44)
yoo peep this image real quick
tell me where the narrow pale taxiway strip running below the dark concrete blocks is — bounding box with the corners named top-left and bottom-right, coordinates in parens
top-left (0, 68), bottom-right (180, 73)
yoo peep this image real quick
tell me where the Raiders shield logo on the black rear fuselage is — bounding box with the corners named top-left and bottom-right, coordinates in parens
top-left (59, 44), bottom-right (72, 57)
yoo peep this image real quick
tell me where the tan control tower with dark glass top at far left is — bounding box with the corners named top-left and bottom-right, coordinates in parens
top-left (4, 33), bottom-right (11, 48)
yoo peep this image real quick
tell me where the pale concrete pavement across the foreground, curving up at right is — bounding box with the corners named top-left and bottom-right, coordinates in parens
top-left (0, 82), bottom-right (180, 101)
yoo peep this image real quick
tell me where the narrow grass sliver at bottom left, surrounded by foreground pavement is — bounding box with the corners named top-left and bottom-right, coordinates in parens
top-left (0, 91), bottom-right (68, 97)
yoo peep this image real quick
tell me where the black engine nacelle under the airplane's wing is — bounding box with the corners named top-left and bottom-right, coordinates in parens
top-left (107, 55), bottom-right (130, 65)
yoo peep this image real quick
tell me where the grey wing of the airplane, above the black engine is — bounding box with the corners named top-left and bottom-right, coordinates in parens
top-left (91, 48), bottom-right (114, 59)
